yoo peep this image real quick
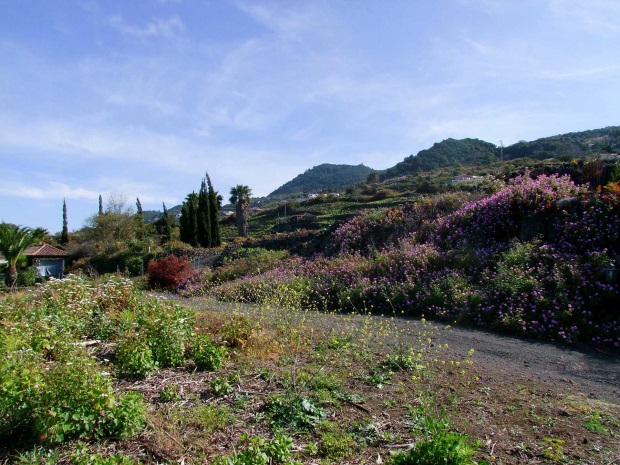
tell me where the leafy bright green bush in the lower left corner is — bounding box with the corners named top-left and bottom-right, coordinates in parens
top-left (0, 350), bottom-right (146, 443)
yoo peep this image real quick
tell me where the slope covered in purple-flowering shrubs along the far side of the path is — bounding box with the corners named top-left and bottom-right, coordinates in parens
top-left (187, 175), bottom-right (620, 350)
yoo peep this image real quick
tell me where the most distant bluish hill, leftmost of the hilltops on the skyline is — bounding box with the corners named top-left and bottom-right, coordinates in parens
top-left (269, 163), bottom-right (374, 197)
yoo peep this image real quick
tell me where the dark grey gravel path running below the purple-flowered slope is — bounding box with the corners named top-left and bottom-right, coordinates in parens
top-left (169, 297), bottom-right (620, 404)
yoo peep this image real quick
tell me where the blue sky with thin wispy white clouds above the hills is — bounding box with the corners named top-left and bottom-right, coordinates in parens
top-left (0, 0), bottom-right (620, 233)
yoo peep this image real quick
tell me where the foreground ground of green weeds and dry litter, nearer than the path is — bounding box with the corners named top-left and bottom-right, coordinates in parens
top-left (0, 277), bottom-right (620, 465)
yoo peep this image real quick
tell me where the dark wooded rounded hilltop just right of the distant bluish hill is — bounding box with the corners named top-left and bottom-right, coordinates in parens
top-left (381, 139), bottom-right (499, 179)
